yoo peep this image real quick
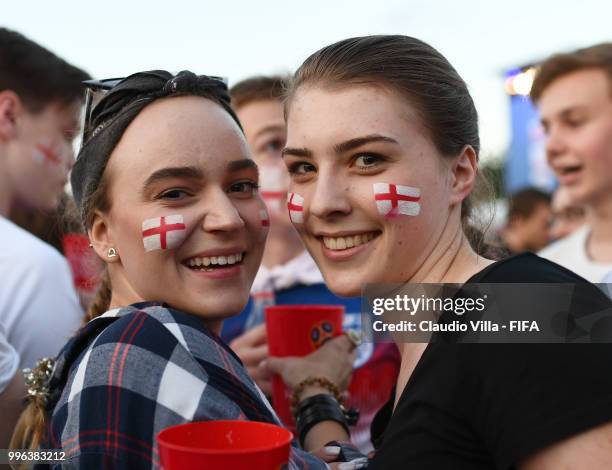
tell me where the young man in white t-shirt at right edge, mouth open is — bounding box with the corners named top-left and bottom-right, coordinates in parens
top-left (531, 43), bottom-right (612, 282)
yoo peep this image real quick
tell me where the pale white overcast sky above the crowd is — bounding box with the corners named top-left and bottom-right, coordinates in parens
top-left (0, 0), bottom-right (612, 160)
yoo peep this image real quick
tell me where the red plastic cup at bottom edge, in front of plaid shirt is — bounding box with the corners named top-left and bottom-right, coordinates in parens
top-left (157, 420), bottom-right (293, 470)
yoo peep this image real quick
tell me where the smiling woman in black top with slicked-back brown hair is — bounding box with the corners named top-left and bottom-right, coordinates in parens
top-left (283, 36), bottom-right (612, 470)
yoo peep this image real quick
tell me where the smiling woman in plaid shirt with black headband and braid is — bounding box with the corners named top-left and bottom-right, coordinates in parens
top-left (12, 71), bottom-right (364, 470)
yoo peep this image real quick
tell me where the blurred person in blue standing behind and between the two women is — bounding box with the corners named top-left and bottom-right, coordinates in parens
top-left (223, 76), bottom-right (399, 452)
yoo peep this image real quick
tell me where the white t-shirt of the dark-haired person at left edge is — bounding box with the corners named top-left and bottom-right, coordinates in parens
top-left (0, 217), bottom-right (83, 367)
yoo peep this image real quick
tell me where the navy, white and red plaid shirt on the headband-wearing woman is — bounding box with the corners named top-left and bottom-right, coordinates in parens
top-left (35, 303), bottom-right (338, 470)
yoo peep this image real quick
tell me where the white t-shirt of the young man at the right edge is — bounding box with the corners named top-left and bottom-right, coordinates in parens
top-left (538, 225), bottom-right (612, 283)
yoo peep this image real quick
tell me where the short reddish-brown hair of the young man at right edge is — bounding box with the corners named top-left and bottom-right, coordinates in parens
top-left (529, 42), bottom-right (612, 103)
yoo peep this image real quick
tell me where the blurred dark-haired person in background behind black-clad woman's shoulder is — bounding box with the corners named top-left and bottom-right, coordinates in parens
top-left (501, 188), bottom-right (552, 253)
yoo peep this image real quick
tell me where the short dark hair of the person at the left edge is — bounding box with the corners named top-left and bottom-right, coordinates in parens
top-left (0, 28), bottom-right (89, 112)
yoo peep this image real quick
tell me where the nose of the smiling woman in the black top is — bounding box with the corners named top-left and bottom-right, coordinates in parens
top-left (308, 169), bottom-right (351, 219)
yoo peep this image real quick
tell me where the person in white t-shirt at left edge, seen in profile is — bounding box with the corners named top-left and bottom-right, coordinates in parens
top-left (0, 28), bottom-right (88, 367)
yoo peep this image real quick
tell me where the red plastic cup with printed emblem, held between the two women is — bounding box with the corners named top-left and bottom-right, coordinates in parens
top-left (266, 305), bottom-right (344, 429)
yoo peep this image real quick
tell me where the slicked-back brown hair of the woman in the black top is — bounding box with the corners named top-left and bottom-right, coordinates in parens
top-left (285, 35), bottom-right (486, 253)
